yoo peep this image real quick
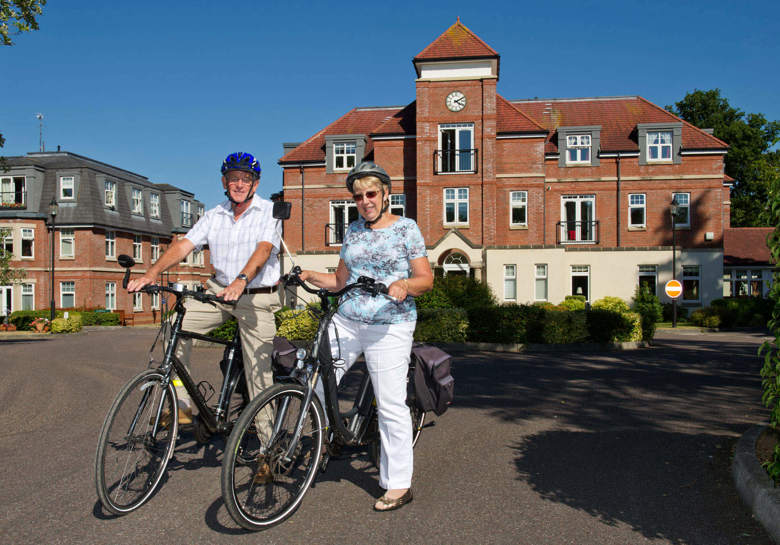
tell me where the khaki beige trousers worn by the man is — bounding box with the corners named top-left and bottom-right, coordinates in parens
top-left (176, 280), bottom-right (281, 406)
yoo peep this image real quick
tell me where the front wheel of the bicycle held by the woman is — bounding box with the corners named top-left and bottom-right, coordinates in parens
top-left (221, 384), bottom-right (324, 530)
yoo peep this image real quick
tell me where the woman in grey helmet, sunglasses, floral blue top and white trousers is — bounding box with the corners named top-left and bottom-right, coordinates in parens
top-left (300, 162), bottom-right (433, 511)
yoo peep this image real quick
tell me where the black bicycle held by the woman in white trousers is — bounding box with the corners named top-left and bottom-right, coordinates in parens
top-left (221, 266), bottom-right (425, 530)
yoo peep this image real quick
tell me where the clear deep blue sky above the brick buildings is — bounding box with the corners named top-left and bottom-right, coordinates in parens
top-left (0, 0), bottom-right (780, 207)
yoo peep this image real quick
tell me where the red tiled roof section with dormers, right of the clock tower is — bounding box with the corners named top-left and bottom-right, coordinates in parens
top-left (512, 96), bottom-right (728, 153)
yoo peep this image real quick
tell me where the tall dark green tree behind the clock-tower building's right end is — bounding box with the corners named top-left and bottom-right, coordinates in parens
top-left (666, 89), bottom-right (780, 227)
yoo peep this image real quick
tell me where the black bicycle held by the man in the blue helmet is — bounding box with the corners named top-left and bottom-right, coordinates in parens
top-left (95, 255), bottom-right (249, 515)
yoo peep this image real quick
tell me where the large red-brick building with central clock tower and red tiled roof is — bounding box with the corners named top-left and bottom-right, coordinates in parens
top-left (279, 20), bottom-right (730, 306)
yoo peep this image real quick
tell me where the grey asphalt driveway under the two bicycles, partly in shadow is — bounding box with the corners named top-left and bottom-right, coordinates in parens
top-left (0, 328), bottom-right (770, 545)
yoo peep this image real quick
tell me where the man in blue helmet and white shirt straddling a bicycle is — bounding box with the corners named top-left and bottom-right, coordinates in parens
top-left (127, 152), bottom-right (281, 424)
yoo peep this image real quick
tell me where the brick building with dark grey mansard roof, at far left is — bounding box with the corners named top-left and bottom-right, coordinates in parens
top-left (0, 151), bottom-right (212, 324)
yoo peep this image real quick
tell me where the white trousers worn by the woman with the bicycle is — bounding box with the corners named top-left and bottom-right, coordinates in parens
top-left (317, 314), bottom-right (415, 490)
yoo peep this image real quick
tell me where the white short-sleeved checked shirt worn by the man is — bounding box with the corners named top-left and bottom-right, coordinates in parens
top-left (186, 194), bottom-right (282, 288)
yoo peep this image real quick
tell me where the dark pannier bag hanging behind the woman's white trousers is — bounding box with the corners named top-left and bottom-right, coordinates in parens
top-left (412, 343), bottom-right (455, 416)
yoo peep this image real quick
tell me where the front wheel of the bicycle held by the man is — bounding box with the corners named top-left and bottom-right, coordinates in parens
top-left (95, 370), bottom-right (178, 515)
